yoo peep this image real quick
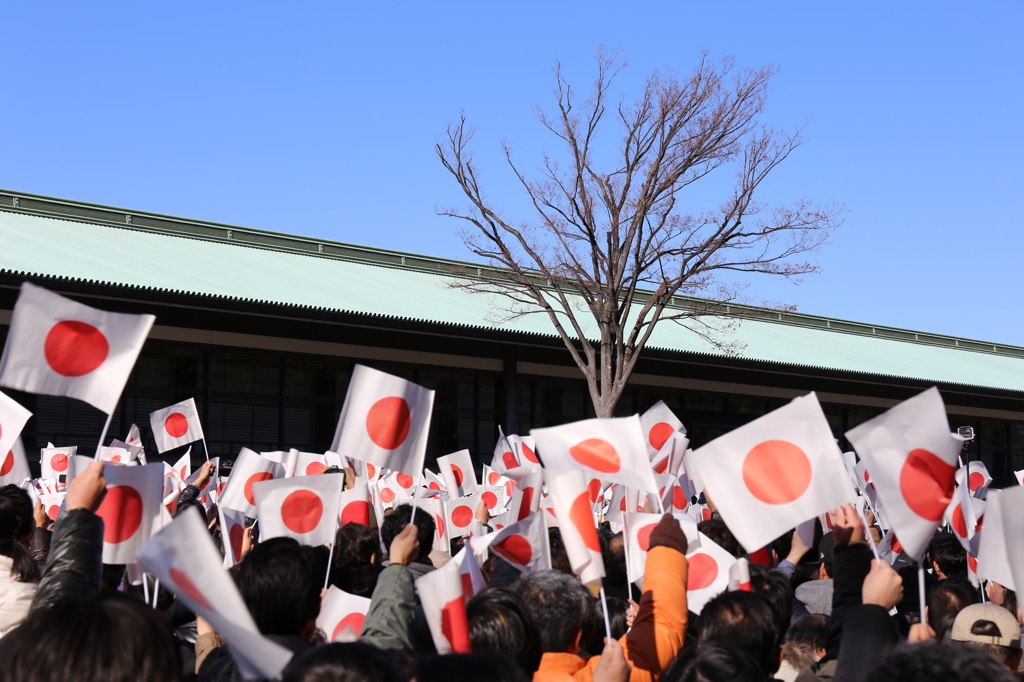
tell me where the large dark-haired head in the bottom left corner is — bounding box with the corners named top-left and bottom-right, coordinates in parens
top-left (0, 595), bottom-right (181, 682)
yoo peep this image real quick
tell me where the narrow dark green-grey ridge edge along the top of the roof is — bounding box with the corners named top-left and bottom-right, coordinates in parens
top-left (0, 183), bottom-right (1024, 357)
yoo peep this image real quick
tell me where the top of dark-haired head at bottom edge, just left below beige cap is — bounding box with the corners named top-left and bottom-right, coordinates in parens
top-left (866, 642), bottom-right (1017, 682)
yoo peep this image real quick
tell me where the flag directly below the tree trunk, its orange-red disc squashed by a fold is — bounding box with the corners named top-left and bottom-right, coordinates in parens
top-left (529, 415), bottom-right (657, 495)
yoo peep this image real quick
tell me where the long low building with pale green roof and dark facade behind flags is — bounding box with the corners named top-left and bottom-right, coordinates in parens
top-left (0, 189), bottom-right (1024, 484)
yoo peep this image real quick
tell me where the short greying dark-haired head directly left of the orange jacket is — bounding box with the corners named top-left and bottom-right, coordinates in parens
top-left (515, 570), bottom-right (584, 653)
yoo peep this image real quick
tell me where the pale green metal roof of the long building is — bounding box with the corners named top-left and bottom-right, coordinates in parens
top-left (0, 189), bottom-right (1024, 391)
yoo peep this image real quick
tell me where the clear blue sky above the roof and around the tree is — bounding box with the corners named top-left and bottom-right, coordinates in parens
top-left (0, 0), bottom-right (1024, 345)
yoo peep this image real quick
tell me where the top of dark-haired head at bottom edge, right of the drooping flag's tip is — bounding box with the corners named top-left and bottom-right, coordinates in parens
top-left (282, 642), bottom-right (409, 682)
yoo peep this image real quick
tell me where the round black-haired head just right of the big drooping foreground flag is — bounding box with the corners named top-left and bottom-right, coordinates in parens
top-left (236, 538), bottom-right (324, 639)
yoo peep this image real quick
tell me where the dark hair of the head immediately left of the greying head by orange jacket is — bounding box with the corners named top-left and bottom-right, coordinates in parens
top-left (466, 587), bottom-right (541, 675)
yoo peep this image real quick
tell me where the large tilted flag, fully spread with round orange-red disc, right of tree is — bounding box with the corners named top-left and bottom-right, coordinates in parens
top-left (686, 393), bottom-right (855, 552)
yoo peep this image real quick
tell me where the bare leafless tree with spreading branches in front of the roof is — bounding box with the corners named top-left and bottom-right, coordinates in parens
top-left (436, 50), bottom-right (843, 417)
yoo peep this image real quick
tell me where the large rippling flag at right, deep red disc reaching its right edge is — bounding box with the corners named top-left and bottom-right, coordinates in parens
top-left (843, 387), bottom-right (964, 560)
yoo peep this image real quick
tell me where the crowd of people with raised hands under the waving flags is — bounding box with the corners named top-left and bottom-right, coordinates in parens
top-left (0, 454), bottom-right (1022, 682)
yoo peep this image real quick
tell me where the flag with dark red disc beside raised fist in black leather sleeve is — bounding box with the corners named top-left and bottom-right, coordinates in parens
top-left (96, 462), bottom-right (164, 563)
